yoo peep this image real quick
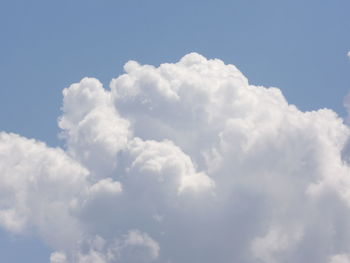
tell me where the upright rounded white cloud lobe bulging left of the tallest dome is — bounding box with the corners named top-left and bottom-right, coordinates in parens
top-left (58, 78), bottom-right (129, 177)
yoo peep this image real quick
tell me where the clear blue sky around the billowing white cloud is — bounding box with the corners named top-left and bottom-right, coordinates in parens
top-left (0, 0), bottom-right (350, 263)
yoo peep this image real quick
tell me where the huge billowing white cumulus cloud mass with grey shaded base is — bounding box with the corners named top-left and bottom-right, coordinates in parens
top-left (0, 53), bottom-right (350, 263)
